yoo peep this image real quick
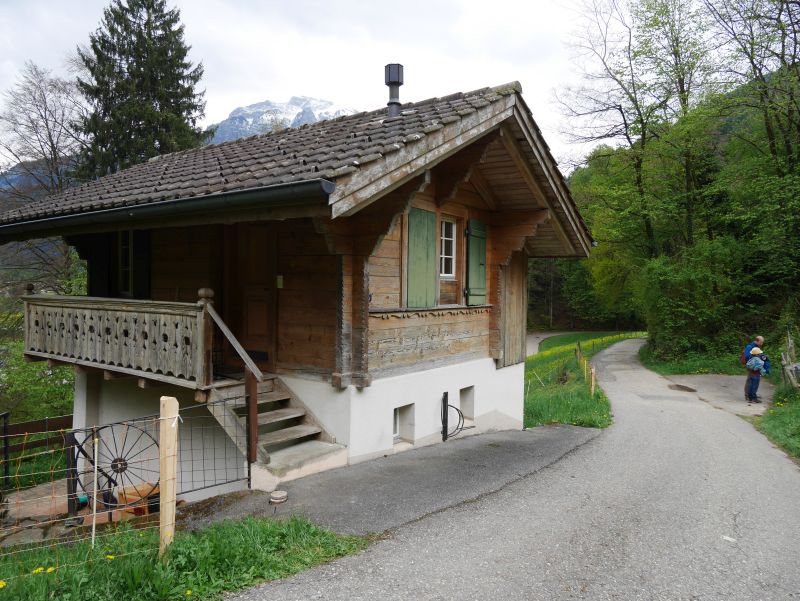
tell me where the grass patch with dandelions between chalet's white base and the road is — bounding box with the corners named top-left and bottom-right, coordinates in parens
top-left (524, 332), bottom-right (646, 428)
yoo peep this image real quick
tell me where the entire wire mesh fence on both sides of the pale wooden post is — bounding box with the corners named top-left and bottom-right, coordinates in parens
top-left (0, 399), bottom-right (248, 587)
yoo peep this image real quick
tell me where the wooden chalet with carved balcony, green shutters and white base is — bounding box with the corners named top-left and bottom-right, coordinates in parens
top-left (0, 78), bottom-right (591, 488)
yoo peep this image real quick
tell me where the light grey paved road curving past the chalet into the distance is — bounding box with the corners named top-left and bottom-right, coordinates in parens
top-left (231, 341), bottom-right (800, 601)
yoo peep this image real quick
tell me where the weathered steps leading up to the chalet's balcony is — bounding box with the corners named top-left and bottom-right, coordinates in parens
top-left (208, 375), bottom-right (344, 473)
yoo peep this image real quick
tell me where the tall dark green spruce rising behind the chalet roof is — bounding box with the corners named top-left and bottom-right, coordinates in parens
top-left (78, 0), bottom-right (208, 179)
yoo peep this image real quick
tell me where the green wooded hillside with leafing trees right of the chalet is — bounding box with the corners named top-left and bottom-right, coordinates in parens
top-left (532, 0), bottom-right (800, 358)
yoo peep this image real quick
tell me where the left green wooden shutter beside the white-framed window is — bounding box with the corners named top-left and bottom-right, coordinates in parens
top-left (407, 209), bottom-right (436, 307)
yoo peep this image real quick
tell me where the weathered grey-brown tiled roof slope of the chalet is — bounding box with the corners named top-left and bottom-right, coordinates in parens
top-left (0, 82), bottom-right (521, 225)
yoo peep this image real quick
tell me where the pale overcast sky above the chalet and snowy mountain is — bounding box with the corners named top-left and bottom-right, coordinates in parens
top-left (0, 0), bottom-right (588, 159)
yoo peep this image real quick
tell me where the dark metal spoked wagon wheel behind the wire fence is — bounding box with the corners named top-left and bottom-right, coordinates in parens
top-left (74, 423), bottom-right (159, 509)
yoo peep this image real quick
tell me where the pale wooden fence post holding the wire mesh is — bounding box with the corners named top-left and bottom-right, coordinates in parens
top-left (158, 396), bottom-right (178, 557)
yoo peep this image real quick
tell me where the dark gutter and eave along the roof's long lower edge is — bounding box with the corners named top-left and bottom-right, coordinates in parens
top-left (0, 179), bottom-right (336, 244)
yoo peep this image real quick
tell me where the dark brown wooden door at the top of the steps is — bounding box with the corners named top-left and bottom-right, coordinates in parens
top-left (226, 223), bottom-right (277, 371)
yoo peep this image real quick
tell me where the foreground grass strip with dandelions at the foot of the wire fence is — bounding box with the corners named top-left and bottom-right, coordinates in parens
top-left (0, 518), bottom-right (367, 601)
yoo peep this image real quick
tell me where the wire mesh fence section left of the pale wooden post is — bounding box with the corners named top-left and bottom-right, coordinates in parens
top-left (0, 417), bottom-right (159, 582)
